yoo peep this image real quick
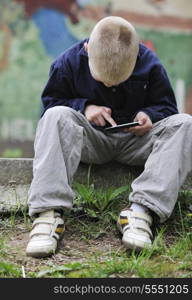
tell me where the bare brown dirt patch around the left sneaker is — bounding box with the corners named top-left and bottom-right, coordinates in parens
top-left (2, 218), bottom-right (123, 273)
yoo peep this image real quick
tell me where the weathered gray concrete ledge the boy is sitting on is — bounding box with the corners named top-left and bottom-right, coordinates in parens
top-left (0, 158), bottom-right (192, 212)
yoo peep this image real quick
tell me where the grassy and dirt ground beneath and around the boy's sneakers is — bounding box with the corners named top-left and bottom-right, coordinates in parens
top-left (0, 184), bottom-right (192, 278)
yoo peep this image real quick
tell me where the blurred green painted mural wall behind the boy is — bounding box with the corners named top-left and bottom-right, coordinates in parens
top-left (0, 0), bottom-right (192, 157)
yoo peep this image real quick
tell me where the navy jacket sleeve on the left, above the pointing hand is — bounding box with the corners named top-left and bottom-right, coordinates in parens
top-left (41, 59), bottom-right (89, 117)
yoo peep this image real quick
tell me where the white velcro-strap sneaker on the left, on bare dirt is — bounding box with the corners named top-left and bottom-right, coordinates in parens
top-left (26, 210), bottom-right (64, 257)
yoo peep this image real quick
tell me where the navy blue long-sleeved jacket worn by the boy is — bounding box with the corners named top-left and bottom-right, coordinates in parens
top-left (42, 40), bottom-right (178, 124)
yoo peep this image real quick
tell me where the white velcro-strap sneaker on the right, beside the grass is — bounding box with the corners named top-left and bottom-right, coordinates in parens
top-left (117, 209), bottom-right (153, 250)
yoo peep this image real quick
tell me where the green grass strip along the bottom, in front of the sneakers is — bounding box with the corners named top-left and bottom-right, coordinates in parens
top-left (26, 233), bottom-right (192, 278)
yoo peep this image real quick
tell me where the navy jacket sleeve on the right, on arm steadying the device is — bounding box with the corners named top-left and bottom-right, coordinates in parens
top-left (137, 58), bottom-right (178, 123)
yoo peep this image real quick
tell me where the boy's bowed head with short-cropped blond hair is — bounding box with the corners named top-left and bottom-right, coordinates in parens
top-left (84, 16), bottom-right (139, 87)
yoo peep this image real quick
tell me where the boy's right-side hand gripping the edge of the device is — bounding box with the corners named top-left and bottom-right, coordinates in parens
top-left (124, 111), bottom-right (153, 136)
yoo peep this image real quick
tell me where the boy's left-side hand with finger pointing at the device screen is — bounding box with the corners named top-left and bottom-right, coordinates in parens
top-left (84, 104), bottom-right (117, 126)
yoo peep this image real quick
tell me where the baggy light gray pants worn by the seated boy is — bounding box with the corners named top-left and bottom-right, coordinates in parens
top-left (29, 106), bottom-right (192, 222)
